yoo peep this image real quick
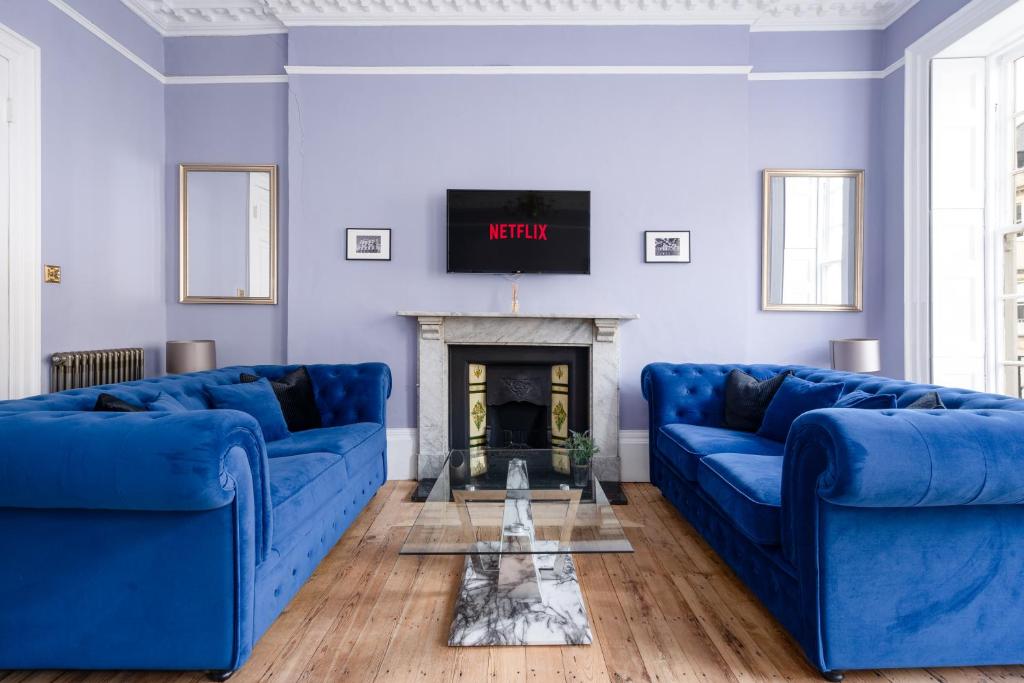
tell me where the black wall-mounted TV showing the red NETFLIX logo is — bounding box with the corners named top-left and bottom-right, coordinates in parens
top-left (447, 189), bottom-right (590, 273)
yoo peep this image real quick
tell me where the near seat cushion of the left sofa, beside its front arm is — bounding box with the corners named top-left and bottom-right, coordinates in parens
top-left (270, 453), bottom-right (348, 548)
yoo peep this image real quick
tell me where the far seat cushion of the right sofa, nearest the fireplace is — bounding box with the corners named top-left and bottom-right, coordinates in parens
top-left (657, 424), bottom-right (784, 481)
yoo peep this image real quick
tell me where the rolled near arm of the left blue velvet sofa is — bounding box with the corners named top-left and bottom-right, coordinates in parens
top-left (0, 411), bottom-right (270, 557)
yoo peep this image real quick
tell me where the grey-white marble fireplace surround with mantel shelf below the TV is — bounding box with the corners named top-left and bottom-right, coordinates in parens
top-left (397, 310), bottom-right (639, 481)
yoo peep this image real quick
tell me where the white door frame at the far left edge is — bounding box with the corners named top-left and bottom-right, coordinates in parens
top-left (0, 24), bottom-right (43, 398)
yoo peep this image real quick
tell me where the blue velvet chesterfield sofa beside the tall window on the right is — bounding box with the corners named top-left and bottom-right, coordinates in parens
top-left (642, 362), bottom-right (1024, 680)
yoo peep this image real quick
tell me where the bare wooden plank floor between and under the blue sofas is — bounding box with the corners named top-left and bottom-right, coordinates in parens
top-left (0, 481), bottom-right (1024, 683)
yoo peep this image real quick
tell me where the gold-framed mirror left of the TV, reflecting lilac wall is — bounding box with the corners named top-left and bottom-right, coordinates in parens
top-left (180, 165), bottom-right (278, 303)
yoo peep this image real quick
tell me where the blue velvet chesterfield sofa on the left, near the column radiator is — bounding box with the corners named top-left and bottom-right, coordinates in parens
top-left (0, 364), bottom-right (391, 677)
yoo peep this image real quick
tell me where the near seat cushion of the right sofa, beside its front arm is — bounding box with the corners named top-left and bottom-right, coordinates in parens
top-left (697, 453), bottom-right (783, 546)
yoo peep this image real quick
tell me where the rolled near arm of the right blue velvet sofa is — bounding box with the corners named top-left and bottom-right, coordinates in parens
top-left (782, 409), bottom-right (1024, 508)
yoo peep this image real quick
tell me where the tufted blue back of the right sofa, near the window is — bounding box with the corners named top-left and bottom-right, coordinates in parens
top-left (640, 362), bottom-right (1024, 444)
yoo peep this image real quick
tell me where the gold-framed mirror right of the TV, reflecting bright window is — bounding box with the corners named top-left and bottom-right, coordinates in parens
top-left (762, 171), bottom-right (863, 310)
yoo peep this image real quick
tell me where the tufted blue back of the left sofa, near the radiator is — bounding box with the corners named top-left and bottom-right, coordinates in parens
top-left (0, 362), bottom-right (391, 426)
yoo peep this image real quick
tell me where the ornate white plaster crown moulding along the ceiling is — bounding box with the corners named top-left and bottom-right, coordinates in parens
top-left (121, 0), bottom-right (919, 36)
